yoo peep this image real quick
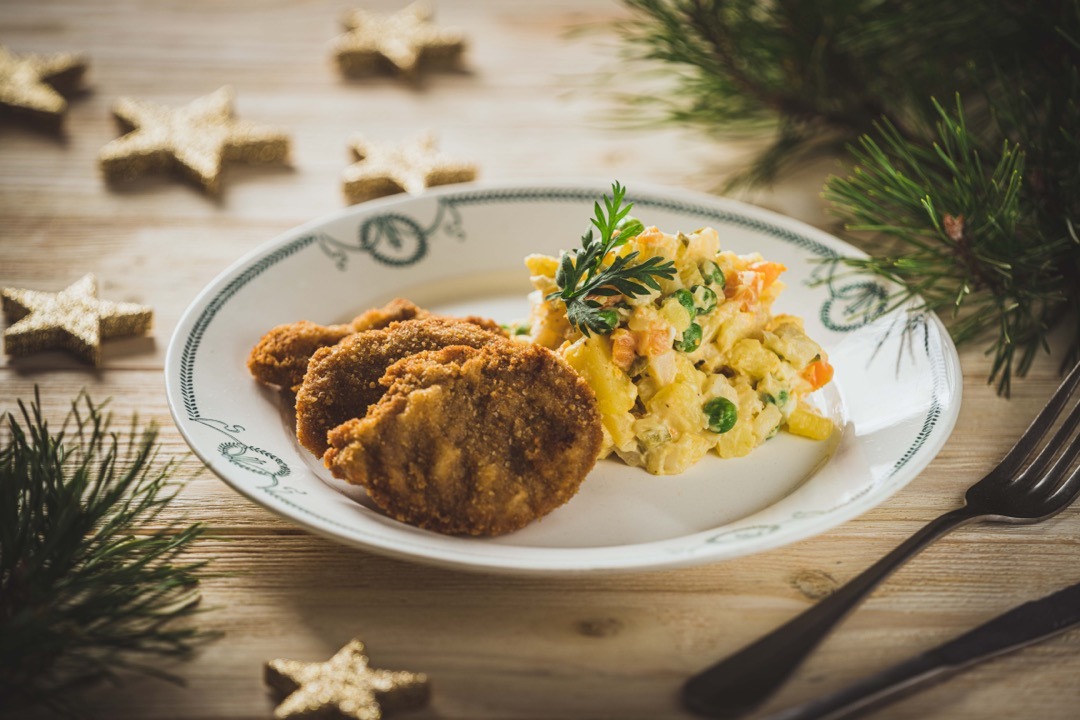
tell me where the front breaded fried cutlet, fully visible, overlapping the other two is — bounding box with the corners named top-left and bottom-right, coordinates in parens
top-left (319, 341), bottom-right (602, 535)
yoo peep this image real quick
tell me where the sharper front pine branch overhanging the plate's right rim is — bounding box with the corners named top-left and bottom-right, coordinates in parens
top-left (825, 98), bottom-right (1080, 394)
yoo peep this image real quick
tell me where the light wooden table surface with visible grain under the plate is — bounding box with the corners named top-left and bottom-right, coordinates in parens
top-left (0, 0), bottom-right (1080, 720)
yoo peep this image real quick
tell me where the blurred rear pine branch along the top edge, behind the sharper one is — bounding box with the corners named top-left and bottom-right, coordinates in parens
top-left (617, 0), bottom-right (1017, 182)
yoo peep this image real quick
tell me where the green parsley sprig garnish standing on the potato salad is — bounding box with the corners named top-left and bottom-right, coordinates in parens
top-left (548, 181), bottom-right (676, 337)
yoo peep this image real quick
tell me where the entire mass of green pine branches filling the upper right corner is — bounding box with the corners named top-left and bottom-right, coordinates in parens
top-left (618, 0), bottom-right (1080, 393)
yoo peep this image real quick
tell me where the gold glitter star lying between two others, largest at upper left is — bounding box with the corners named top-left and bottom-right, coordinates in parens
top-left (98, 86), bottom-right (288, 194)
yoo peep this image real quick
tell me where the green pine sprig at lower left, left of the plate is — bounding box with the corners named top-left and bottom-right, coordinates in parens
top-left (0, 389), bottom-right (212, 711)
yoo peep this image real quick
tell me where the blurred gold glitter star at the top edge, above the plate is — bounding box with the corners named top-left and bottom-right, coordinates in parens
top-left (334, 3), bottom-right (465, 80)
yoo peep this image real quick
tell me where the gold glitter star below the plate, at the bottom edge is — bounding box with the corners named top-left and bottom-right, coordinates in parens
top-left (266, 640), bottom-right (431, 720)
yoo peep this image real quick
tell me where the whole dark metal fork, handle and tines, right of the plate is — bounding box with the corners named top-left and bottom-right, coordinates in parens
top-left (683, 364), bottom-right (1080, 720)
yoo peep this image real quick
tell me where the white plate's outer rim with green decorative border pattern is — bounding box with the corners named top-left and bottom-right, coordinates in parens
top-left (166, 182), bottom-right (961, 573)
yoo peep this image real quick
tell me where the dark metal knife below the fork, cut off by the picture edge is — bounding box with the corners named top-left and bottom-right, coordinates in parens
top-left (762, 583), bottom-right (1080, 720)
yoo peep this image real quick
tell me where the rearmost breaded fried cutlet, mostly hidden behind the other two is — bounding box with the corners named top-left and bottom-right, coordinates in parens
top-left (247, 298), bottom-right (431, 392)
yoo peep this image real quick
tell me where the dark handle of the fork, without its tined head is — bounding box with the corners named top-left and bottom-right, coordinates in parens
top-left (683, 507), bottom-right (981, 720)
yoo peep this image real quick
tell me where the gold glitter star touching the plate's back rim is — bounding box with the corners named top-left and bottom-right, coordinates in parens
top-left (341, 134), bottom-right (476, 203)
